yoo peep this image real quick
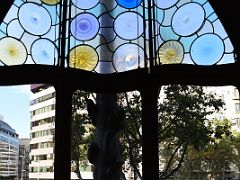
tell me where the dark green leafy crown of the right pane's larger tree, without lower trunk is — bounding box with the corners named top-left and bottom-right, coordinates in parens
top-left (159, 85), bottom-right (223, 149)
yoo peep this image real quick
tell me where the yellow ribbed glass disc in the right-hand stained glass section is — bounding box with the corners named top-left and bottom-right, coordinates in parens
top-left (158, 41), bottom-right (184, 64)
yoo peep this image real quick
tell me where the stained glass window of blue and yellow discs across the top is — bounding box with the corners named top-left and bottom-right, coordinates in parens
top-left (0, 0), bottom-right (234, 73)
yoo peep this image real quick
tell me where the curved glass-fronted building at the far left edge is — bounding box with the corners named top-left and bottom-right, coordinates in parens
top-left (0, 116), bottom-right (19, 179)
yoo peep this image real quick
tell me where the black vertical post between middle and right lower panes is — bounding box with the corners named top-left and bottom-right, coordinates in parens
top-left (141, 87), bottom-right (159, 180)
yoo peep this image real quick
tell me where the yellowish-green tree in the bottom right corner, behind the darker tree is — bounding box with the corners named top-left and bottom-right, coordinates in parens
top-left (180, 119), bottom-right (234, 179)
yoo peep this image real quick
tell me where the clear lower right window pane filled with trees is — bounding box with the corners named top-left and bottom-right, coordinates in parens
top-left (158, 84), bottom-right (240, 179)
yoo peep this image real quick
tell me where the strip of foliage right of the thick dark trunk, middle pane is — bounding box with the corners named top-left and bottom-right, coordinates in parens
top-left (119, 91), bottom-right (142, 178)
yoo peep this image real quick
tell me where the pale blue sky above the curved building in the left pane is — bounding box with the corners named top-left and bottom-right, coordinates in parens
top-left (0, 85), bottom-right (31, 138)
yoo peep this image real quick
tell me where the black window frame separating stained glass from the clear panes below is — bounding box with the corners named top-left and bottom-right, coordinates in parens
top-left (0, 0), bottom-right (240, 180)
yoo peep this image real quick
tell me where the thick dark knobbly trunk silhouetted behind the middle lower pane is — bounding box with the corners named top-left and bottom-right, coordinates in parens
top-left (88, 94), bottom-right (124, 180)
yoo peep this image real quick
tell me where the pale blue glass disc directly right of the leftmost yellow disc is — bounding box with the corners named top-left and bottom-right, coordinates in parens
top-left (31, 39), bottom-right (58, 65)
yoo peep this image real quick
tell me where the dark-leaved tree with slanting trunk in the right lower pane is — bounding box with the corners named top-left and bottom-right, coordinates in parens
top-left (159, 85), bottom-right (224, 179)
